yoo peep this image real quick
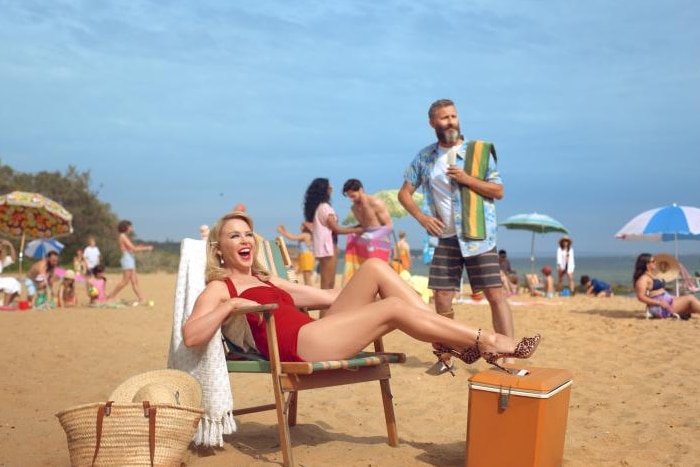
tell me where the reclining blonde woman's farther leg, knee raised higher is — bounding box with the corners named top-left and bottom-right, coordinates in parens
top-left (326, 258), bottom-right (433, 315)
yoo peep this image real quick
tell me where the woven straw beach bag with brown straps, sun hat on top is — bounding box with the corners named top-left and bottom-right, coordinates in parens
top-left (56, 370), bottom-right (204, 467)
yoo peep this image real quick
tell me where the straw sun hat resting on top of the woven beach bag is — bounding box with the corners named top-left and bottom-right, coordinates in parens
top-left (109, 369), bottom-right (202, 407)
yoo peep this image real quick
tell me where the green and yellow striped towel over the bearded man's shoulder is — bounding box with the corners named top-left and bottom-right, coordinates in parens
top-left (461, 141), bottom-right (496, 240)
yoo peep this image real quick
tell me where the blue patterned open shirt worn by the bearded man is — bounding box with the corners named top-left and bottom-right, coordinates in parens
top-left (404, 141), bottom-right (503, 257)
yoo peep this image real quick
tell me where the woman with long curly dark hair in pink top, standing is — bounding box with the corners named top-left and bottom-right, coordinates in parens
top-left (304, 178), bottom-right (362, 289)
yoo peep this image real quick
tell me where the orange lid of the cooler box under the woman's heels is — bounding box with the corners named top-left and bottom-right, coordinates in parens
top-left (469, 364), bottom-right (573, 399)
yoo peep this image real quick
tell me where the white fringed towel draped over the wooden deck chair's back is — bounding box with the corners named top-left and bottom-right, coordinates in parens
top-left (168, 238), bottom-right (255, 446)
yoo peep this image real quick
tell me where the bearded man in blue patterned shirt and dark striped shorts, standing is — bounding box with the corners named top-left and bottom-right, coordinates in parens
top-left (399, 99), bottom-right (515, 372)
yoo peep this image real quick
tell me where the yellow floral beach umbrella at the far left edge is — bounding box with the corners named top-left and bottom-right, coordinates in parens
top-left (0, 191), bottom-right (73, 276)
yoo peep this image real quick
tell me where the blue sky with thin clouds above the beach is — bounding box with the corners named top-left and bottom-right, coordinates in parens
top-left (0, 0), bottom-right (700, 256)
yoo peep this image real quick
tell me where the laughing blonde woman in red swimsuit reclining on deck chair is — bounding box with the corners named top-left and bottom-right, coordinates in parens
top-left (183, 211), bottom-right (540, 372)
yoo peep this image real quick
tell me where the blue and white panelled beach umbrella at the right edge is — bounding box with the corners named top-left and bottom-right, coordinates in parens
top-left (615, 204), bottom-right (700, 247)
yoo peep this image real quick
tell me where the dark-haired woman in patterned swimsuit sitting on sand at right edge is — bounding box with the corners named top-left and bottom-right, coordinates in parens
top-left (634, 253), bottom-right (700, 319)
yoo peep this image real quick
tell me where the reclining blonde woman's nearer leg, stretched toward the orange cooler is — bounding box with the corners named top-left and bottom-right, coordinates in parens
top-left (297, 297), bottom-right (515, 361)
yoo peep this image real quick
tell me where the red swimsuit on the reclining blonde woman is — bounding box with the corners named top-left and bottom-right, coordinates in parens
top-left (226, 278), bottom-right (314, 362)
